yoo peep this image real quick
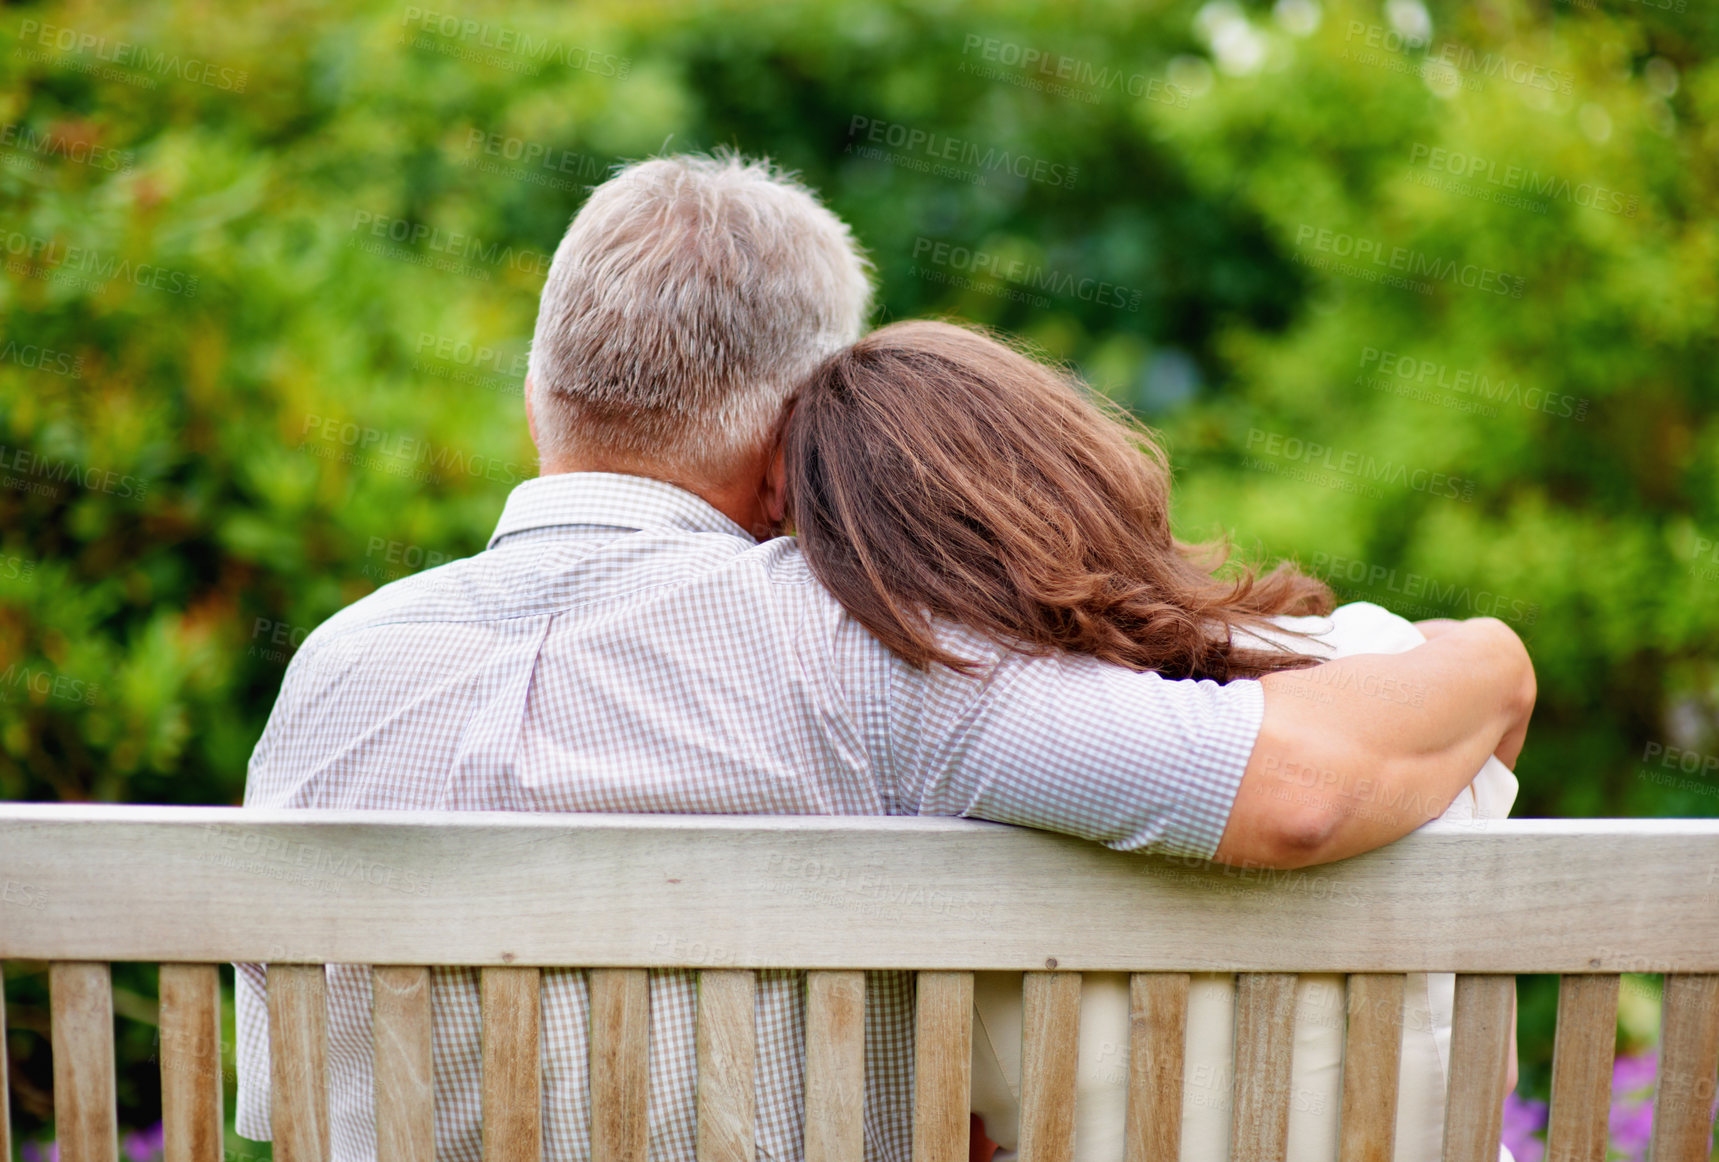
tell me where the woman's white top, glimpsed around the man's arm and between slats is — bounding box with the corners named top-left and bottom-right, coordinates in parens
top-left (973, 602), bottom-right (1518, 1162)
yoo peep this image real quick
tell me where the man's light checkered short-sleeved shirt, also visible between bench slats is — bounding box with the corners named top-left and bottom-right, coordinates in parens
top-left (237, 473), bottom-right (1263, 1162)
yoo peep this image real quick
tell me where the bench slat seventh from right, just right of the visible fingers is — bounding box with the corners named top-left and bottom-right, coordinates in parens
top-left (1019, 973), bottom-right (1081, 1162)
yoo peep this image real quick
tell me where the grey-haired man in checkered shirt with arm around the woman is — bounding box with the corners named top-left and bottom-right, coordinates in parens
top-left (237, 156), bottom-right (1533, 1162)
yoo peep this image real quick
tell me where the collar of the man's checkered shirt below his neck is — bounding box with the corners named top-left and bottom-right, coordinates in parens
top-left (488, 473), bottom-right (753, 548)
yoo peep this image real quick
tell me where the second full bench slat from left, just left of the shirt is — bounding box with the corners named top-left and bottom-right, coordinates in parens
top-left (160, 964), bottom-right (225, 1162)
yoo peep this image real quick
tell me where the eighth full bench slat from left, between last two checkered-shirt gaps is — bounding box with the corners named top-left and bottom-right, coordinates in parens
top-left (806, 971), bottom-right (865, 1162)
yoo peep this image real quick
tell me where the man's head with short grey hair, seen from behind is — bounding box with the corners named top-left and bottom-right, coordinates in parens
top-left (529, 153), bottom-right (872, 483)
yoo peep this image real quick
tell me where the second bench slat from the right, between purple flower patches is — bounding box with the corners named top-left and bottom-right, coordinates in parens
top-left (1545, 973), bottom-right (1619, 1162)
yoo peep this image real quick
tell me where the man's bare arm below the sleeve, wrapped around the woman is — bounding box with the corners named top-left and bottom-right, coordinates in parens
top-left (1214, 617), bottom-right (1535, 868)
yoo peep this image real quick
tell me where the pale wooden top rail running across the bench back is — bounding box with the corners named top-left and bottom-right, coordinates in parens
top-left (0, 803), bottom-right (1719, 973)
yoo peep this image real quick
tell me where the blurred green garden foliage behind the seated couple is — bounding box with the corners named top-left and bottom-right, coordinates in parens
top-left (0, 0), bottom-right (1719, 1148)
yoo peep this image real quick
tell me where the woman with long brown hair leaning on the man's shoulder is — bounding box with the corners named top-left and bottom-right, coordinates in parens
top-left (784, 321), bottom-right (1516, 1162)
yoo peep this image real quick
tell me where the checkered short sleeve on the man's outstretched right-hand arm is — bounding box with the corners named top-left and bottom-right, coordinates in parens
top-left (885, 641), bottom-right (1265, 859)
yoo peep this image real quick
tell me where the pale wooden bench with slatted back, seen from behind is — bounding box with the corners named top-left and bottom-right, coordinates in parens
top-left (0, 804), bottom-right (1719, 1162)
